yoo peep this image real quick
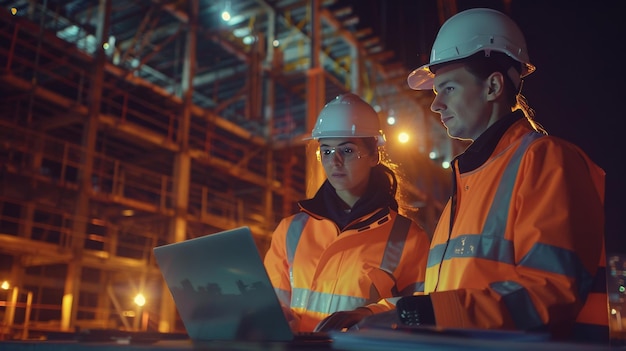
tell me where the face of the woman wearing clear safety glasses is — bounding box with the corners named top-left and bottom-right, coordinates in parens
top-left (319, 138), bottom-right (378, 198)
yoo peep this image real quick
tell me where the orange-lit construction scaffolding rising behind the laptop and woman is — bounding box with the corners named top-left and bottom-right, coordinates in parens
top-left (0, 0), bottom-right (447, 339)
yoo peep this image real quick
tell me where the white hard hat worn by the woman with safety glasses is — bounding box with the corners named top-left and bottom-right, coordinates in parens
top-left (305, 93), bottom-right (385, 146)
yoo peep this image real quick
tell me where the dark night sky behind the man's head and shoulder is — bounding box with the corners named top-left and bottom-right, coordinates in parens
top-left (346, 0), bottom-right (626, 254)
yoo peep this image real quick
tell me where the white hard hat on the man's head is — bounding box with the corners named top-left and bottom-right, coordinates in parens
top-left (407, 8), bottom-right (535, 90)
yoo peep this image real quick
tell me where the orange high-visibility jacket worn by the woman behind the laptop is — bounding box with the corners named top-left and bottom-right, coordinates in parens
top-left (265, 201), bottom-right (430, 331)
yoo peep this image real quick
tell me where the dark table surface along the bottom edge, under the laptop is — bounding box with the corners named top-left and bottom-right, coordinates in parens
top-left (0, 330), bottom-right (626, 351)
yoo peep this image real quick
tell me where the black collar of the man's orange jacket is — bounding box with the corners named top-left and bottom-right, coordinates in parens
top-left (457, 110), bottom-right (526, 173)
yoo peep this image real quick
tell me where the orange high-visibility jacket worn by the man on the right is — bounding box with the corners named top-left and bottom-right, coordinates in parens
top-left (424, 112), bottom-right (608, 341)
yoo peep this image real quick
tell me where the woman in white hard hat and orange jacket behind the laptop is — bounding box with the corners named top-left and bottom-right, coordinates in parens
top-left (265, 94), bottom-right (429, 331)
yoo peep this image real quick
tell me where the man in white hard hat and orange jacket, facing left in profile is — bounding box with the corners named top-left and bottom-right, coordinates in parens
top-left (314, 8), bottom-right (609, 343)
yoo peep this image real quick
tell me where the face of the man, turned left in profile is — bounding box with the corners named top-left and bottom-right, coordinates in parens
top-left (430, 63), bottom-right (493, 140)
